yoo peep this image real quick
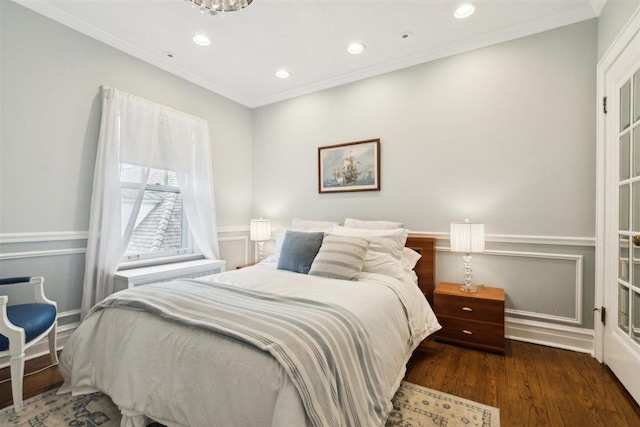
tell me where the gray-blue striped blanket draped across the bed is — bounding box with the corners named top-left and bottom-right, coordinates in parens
top-left (89, 280), bottom-right (391, 427)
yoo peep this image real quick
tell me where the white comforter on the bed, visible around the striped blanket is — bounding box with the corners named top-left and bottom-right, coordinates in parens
top-left (60, 263), bottom-right (440, 427)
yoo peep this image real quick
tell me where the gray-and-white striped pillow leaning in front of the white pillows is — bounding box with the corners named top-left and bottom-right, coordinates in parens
top-left (309, 235), bottom-right (369, 280)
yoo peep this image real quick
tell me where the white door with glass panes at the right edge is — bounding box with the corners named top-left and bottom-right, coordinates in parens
top-left (603, 14), bottom-right (640, 403)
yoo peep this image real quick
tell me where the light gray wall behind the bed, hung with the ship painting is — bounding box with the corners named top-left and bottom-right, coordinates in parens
top-left (253, 20), bottom-right (597, 348)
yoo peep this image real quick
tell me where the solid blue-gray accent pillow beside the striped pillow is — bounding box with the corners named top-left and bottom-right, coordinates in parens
top-left (278, 231), bottom-right (324, 274)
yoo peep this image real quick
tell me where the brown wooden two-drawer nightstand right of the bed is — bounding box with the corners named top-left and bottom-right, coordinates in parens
top-left (433, 283), bottom-right (504, 354)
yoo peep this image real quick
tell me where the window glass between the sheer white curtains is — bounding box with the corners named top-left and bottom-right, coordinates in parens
top-left (120, 163), bottom-right (193, 262)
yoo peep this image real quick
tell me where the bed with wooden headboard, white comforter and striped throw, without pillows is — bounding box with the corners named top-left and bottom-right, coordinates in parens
top-left (59, 231), bottom-right (440, 427)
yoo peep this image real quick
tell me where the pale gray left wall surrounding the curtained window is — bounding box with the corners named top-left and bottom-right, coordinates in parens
top-left (0, 0), bottom-right (252, 320)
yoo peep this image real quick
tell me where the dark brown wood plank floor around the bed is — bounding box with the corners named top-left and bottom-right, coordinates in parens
top-left (0, 340), bottom-right (640, 427)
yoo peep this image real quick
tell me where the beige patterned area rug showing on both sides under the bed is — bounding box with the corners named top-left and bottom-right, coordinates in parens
top-left (0, 381), bottom-right (500, 427)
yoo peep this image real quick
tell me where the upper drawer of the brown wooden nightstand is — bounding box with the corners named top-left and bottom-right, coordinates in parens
top-left (433, 294), bottom-right (504, 323)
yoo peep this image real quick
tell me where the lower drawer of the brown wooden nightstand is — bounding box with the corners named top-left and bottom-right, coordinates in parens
top-left (436, 316), bottom-right (504, 352)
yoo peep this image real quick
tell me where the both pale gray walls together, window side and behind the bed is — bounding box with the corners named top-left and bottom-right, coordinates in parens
top-left (0, 0), bottom-right (611, 348)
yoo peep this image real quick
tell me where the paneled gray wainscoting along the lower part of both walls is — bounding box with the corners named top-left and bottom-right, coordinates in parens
top-left (0, 231), bottom-right (595, 366)
